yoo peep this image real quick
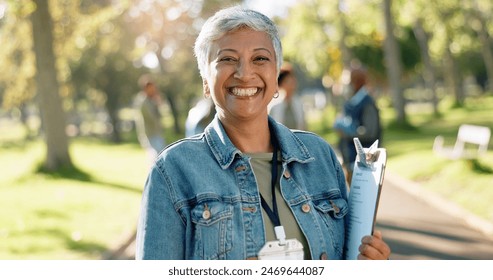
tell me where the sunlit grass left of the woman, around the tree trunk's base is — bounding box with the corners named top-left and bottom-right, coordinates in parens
top-left (0, 137), bottom-right (148, 259)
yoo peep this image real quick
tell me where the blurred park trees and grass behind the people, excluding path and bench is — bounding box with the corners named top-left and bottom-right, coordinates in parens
top-left (0, 0), bottom-right (493, 259)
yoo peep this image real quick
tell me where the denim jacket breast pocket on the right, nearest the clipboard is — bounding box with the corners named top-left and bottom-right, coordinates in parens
top-left (313, 196), bottom-right (349, 254)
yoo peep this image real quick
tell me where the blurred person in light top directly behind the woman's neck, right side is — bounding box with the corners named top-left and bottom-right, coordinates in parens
top-left (269, 63), bottom-right (306, 130)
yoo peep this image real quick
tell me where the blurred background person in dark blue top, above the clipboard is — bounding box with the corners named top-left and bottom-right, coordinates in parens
top-left (334, 67), bottom-right (382, 186)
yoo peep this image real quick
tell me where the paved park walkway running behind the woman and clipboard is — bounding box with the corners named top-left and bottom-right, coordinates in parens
top-left (109, 172), bottom-right (493, 260)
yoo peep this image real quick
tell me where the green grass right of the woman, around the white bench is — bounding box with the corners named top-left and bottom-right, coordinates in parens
top-left (311, 96), bottom-right (493, 221)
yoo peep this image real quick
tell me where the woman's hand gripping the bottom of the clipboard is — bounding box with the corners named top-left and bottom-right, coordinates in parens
top-left (358, 230), bottom-right (390, 260)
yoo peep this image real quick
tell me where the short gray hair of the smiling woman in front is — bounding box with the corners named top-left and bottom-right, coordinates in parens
top-left (194, 6), bottom-right (282, 79)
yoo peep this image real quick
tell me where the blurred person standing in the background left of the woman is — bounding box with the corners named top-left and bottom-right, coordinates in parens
top-left (135, 74), bottom-right (165, 160)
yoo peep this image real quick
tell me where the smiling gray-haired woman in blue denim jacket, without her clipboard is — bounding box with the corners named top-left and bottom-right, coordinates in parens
top-left (136, 4), bottom-right (390, 259)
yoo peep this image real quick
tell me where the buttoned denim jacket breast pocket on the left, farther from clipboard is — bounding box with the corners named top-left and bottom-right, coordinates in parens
top-left (191, 201), bottom-right (233, 260)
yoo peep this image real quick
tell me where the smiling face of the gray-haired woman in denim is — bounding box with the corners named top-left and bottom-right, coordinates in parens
top-left (204, 28), bottom-right (277, 121)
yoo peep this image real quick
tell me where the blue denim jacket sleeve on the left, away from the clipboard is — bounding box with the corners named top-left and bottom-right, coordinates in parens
top-left (135, 166), bottom-right (186, 260)
